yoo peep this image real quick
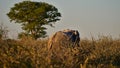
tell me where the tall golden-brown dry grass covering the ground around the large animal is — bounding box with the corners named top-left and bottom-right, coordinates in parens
top-left (0, 36), bottom-right (120, 68)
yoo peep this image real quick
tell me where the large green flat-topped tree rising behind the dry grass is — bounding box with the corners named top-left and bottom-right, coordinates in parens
top-left (7, 1), bottom-right (61, 39)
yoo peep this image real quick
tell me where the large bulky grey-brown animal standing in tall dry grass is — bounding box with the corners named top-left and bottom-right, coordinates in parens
top-left (48, 29), bottom-right (80, 50)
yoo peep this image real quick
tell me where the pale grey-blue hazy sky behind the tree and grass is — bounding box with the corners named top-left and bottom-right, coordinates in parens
top-left (0, 0), bottom-right (120, 38)
